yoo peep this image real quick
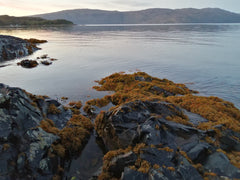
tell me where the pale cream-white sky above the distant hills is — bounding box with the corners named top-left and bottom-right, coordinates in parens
top-left (0, 0), bottom-right (240, 16)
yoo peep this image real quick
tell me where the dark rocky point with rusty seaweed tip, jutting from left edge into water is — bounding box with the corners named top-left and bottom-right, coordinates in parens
top-left (0, 35), bottom-right (47, 61)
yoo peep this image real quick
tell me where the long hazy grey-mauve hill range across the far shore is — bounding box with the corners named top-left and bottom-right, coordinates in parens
top-left (32, 8), bottom-right (240, 24)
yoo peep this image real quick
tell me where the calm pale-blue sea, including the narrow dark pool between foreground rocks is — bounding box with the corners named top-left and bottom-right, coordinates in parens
top-left (0, 24), bottom-right (240, 178)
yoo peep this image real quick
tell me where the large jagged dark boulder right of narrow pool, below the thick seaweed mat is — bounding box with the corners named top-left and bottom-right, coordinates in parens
top-left (95, 100), bottom-right (240, 179)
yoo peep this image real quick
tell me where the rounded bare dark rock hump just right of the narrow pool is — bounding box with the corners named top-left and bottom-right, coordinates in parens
top-left (96, 101), bottom-right (201, 149)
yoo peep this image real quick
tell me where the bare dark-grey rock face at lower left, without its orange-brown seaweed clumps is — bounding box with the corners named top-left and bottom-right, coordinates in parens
top-left (0, 84), bottom-right (71, 179)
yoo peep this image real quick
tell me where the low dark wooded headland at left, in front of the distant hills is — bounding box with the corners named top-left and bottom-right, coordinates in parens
top-left (0, 15), bottom-right (73, 26)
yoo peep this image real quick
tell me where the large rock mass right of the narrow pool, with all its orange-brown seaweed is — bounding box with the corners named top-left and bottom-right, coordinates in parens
top-left (91, 73), bottom-right (240, 179)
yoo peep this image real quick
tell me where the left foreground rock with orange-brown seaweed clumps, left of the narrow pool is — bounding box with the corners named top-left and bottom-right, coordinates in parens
top-left (0, 84), bottom-right (93, 179)
